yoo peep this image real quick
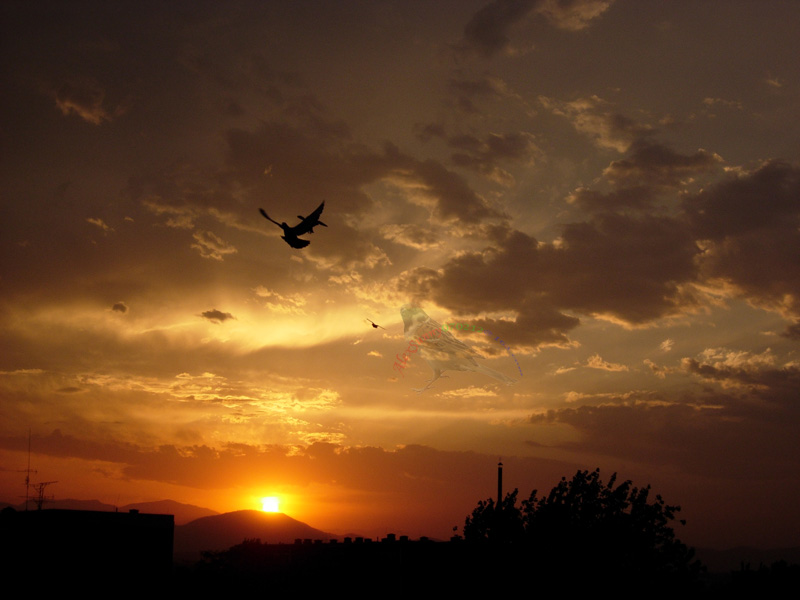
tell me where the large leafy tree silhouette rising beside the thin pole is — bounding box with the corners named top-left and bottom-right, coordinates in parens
top-left (464, 469), bottom-right (702, 584)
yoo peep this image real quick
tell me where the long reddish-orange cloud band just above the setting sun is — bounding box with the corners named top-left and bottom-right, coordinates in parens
top-left (0, 428), bottom-right (575, 504)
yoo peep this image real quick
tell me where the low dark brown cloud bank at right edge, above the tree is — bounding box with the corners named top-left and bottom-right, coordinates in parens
top-left (531, 393), bottom-right (800, 480)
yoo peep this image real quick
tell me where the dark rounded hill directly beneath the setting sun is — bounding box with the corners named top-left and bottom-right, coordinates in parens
top-left (174, 510), bottom-right (339, 560)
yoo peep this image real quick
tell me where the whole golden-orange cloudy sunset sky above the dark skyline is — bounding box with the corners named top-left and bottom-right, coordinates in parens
top-left (0, 0), bottom-right (800, 547)
